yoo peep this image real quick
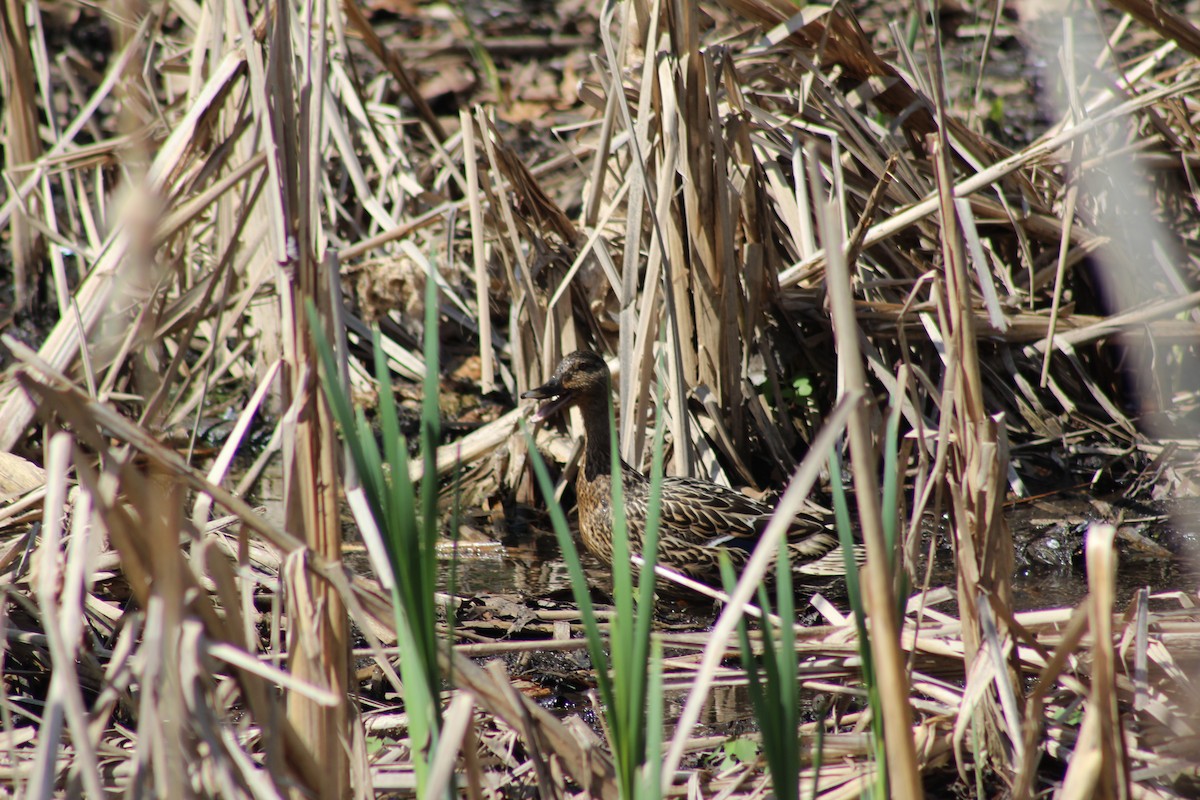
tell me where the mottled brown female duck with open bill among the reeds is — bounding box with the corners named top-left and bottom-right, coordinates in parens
top-left (522, 350), bottom-right (839, 585)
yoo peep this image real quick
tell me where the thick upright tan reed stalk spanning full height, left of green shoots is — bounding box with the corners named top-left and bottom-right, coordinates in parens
top-left (256, 2), bottom-right (350, 800)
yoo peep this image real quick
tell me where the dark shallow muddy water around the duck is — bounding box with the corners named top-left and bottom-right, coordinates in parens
top-left (420, 495), bottom-right (1200, 736)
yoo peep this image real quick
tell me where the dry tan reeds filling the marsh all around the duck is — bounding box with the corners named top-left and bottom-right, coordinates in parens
top-left (0, 0), bottom-right (1200, 798)
